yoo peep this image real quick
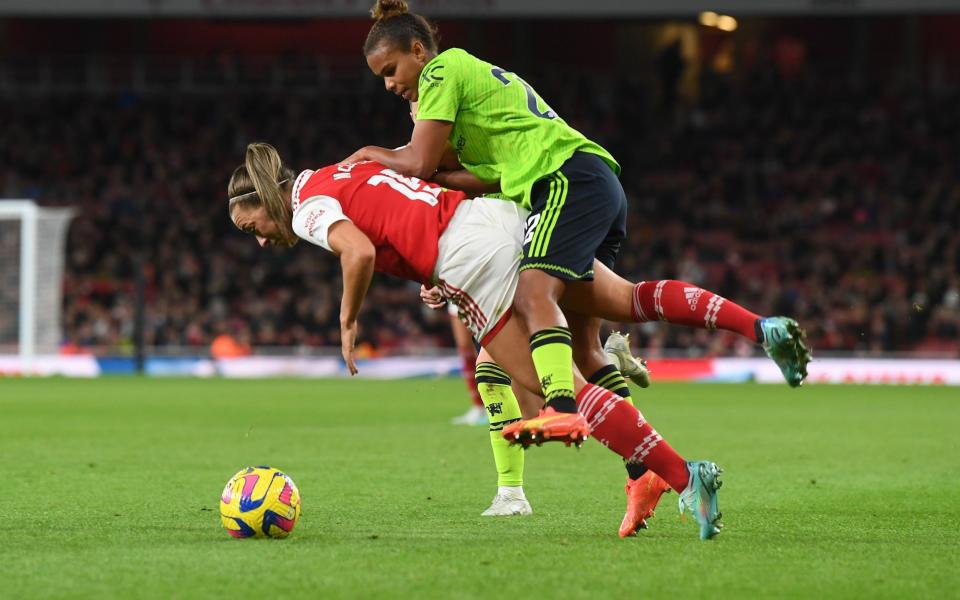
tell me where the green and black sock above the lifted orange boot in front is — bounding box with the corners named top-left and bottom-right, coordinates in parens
top-left (530, 327), bottom-right (577, 412)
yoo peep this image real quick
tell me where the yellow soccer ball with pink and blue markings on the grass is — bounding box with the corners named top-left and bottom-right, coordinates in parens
top-left (220, 467), bottom-right (300, 538)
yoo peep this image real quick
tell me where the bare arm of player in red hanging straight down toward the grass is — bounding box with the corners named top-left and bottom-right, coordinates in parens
top-left (327, 220), bottom-right (377, 375)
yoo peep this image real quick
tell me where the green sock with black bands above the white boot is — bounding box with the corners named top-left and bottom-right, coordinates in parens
top-left (476, 362), bottom-right (523, 486)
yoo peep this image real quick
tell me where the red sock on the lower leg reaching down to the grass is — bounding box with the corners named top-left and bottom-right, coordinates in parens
top-left (577, 383), bottom-right (690, 492)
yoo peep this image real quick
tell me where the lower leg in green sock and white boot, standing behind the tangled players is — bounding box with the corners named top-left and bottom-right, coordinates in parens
top-left (476, 349), bottom-right (533, 517)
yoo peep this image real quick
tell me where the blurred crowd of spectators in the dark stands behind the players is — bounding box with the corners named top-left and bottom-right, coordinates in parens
top-left (0, 52), bottom-right (960, 355)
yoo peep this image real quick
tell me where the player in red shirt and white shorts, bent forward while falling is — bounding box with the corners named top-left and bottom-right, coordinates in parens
top-left (228, 144), bottom-right (808, 538)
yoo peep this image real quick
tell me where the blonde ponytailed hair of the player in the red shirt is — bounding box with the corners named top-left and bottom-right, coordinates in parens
top-left (227, 143), bottom-right (299, 246)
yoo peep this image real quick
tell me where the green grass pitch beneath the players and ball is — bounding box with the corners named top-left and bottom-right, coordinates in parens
top-left (0, 378), bottom-right (960, 598)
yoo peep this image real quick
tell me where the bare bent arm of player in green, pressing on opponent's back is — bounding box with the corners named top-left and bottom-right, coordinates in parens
top-left (340, 120), bottom-right (453, 179)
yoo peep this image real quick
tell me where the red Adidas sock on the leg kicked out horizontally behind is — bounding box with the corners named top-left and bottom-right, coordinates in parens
top-left (632, 279), bottom-right (760, 342)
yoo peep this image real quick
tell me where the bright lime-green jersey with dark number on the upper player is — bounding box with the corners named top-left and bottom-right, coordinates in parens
top-left (417, 48), bottom-right (620, 208)
